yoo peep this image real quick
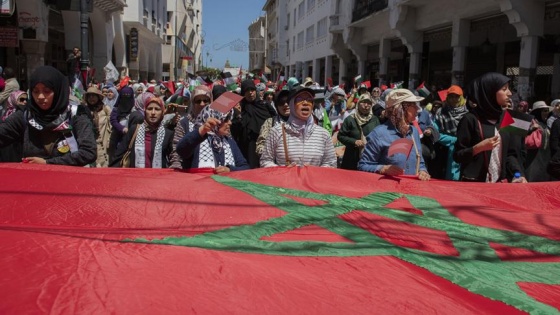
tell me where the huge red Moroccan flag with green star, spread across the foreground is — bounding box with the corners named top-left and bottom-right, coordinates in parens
top-left (0, 164), bottom-right (560, 314)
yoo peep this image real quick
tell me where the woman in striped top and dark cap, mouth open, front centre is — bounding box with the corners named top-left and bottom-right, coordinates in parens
top-left (260, 86), bottom-right (336, 167)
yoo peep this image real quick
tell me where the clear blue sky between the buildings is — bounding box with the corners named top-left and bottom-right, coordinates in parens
top-left (202, 0), bottom-right (266, 69)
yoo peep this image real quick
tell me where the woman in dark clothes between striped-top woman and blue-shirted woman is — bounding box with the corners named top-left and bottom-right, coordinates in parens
top-left (338, 93), bottom-right (379, 170)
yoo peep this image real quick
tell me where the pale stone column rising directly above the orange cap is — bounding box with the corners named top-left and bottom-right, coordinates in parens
top-left (451, 19), bottom-right (471, 86)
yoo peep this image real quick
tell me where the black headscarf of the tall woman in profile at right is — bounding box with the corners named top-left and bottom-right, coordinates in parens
top-left (465, 72), bottom-right (510, 120)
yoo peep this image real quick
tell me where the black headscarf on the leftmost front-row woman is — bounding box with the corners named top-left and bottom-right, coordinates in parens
top-left (27, 66), bottom-right (70, 128)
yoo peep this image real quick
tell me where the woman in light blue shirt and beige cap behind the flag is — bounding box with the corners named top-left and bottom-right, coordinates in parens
top-left (358, 89), bottom-right (430, 180)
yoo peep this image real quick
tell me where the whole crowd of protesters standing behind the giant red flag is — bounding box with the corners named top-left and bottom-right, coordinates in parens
top-left (0, 66), bottom-right (560, 183)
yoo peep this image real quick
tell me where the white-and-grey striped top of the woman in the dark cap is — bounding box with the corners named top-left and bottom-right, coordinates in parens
top-left (260, 123), bottom-right (336, 167)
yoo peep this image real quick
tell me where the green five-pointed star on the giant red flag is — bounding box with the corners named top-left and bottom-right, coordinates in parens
top-left (135, 176), bottom-right (560, 314)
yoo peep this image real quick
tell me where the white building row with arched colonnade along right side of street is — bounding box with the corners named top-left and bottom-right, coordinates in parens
top-left (263, 0), bottom-right (560, 100)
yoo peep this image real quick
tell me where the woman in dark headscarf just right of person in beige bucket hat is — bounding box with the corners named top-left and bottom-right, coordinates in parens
top-left (106, 87), bottom-right (136, 164)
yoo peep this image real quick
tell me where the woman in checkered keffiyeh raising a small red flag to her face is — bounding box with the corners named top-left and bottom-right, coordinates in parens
top-left (177, 105), bottom-right (249, 174)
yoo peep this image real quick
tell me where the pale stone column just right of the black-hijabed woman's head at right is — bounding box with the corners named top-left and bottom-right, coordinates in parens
top-left (517, 36), bottom-right (539, 100)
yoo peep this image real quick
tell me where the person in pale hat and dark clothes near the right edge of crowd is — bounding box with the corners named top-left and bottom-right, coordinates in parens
top-left (524, 101), bottom-right (552, 182)
